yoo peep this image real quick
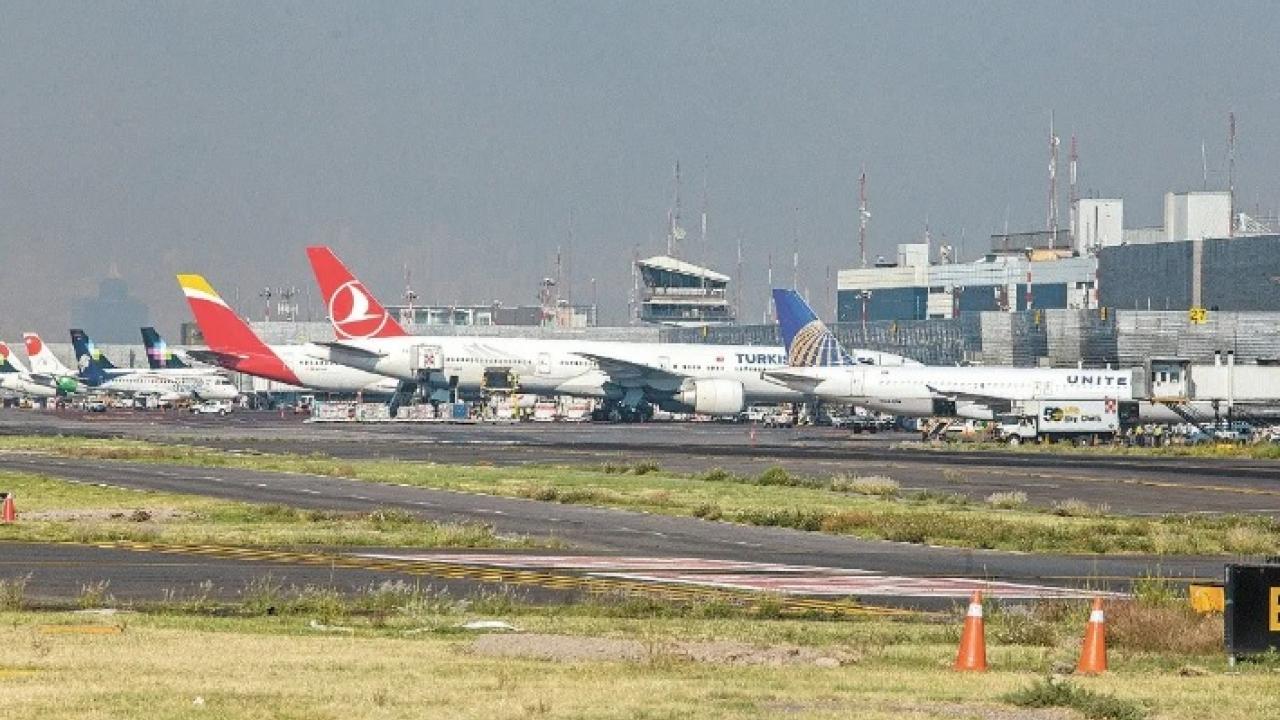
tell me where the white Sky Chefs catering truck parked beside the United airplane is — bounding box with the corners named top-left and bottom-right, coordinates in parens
top-left (996, 398), bottom-right (1138, 445)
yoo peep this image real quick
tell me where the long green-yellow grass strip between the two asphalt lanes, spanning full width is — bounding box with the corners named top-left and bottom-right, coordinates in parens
top-left (0, 430), bottom-right (1280, 555)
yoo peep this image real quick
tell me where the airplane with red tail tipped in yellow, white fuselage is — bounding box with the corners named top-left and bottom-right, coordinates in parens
top-left (178, 274), bottom-right (401, 396)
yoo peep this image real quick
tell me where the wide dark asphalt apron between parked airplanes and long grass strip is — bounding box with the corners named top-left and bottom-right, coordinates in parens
top-left (0, 410), bottom-right (1280, 516)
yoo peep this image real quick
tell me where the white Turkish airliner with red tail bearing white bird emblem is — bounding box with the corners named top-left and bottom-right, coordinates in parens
top-left (299, 246), bottom-right (914, 419)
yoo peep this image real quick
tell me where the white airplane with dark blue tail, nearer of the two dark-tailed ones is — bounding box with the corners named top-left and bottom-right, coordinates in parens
top-left (70, 329), bottom-right (239, 402)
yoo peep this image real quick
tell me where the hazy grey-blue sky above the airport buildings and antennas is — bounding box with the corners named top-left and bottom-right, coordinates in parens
top-left (0, 1), bottom-right (1280, 340)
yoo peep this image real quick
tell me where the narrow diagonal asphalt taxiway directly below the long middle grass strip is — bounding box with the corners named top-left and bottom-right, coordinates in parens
top-left (0, 454), bottom-right (1222, 584)
